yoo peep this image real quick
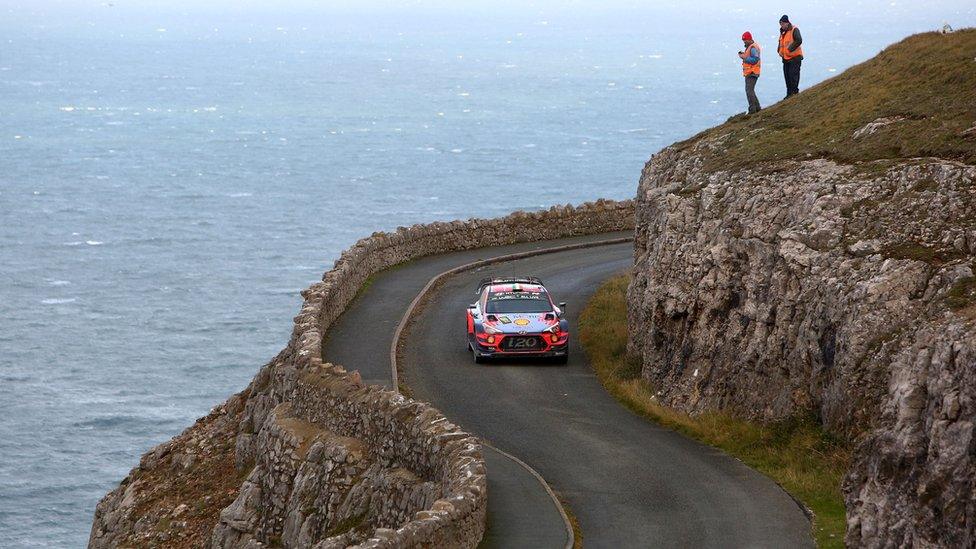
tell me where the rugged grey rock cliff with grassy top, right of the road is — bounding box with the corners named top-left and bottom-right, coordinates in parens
top-left (628, 30), bottom-right (976, 547)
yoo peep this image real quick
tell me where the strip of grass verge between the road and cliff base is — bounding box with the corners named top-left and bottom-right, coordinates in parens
top-left (579, 276), bottom-right (850, 547)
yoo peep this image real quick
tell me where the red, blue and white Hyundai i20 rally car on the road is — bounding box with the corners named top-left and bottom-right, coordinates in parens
top-left (466, 277), bottom-right (569, 364)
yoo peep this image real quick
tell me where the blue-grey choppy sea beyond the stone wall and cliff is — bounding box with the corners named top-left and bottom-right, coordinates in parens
top-left (0, 0), bottom-right (976, 547)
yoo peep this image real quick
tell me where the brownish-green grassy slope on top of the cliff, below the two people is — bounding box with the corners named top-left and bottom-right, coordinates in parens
top-left (677, 29), bottom-right (976, 170)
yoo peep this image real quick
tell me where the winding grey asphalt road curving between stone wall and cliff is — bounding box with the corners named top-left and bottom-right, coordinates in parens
top-left (323, 233), bottom-right (813, 547)
